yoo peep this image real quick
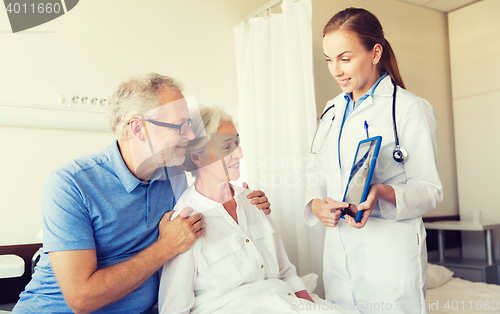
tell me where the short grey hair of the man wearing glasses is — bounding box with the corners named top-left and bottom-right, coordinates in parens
top-left (108, 73), bottom-right (182, 140)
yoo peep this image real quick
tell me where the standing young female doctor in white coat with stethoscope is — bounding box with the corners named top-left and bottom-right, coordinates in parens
top-left (304, 8), bottom-right (443, 313)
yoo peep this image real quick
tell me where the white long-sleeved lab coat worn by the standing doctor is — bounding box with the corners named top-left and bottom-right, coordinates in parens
top-left (304, 76), bottom-right (443, 313)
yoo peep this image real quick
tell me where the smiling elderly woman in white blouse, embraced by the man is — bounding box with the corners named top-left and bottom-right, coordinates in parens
top-left (159, 107), bottom-right (346, 314)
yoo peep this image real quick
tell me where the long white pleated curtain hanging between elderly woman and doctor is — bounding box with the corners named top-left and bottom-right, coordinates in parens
top-left (234, 0), bottom-right (324, 294)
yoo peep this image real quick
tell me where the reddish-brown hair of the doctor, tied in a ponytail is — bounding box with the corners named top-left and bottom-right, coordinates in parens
top-left (323, 8), bottom-right (405, 88)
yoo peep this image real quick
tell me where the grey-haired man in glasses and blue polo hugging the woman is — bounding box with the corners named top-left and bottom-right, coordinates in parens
top-left (13, 73), bottom-right (269, 313)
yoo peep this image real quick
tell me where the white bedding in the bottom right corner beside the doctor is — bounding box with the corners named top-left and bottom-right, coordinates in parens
top-left (426, 278), bottom-right (500, 314)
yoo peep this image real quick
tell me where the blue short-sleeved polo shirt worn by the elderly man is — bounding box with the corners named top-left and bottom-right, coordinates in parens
top-left (13, 141), bottom-right (187, 313)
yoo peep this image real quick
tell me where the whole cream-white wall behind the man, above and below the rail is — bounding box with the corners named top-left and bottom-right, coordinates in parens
top-left (0, 0), bottom-right (267, 245)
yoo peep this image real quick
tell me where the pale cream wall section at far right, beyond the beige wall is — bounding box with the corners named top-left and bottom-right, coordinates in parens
top-left (449, 0), bottom-right (500, 258)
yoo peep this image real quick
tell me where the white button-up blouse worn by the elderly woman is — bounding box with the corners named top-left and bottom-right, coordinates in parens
top-left (159, 185), bottom-right (305, 314)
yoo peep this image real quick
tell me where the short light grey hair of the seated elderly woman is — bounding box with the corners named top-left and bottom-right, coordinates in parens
top-left (181, 106), bottom-right (233, 174)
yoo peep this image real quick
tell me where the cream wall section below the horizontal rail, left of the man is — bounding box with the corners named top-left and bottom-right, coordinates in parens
top-left (0, 127), bottom-right (113, 245)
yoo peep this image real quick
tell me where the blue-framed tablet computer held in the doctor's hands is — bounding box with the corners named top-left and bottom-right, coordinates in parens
top-left (342, 136), bottom-right (382, 222)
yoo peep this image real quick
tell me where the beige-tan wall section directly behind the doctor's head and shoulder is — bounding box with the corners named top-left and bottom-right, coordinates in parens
top-left (313, 0), bottom-right (458, 216)
